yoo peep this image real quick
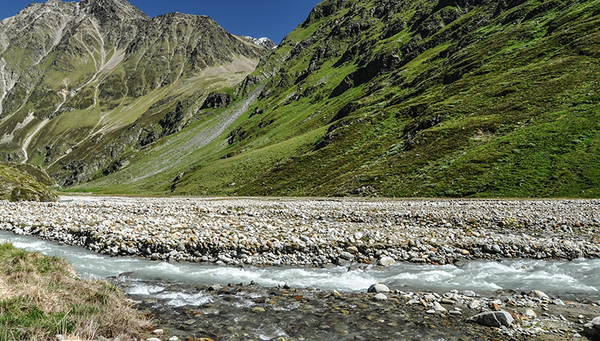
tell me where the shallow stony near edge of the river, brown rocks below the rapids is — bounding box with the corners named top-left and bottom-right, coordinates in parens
top-left (122, 276), bottom-right (600, 341)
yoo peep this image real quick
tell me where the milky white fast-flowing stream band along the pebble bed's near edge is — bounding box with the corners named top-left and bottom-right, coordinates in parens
top-left (0, 232), bottom-right (600, 305)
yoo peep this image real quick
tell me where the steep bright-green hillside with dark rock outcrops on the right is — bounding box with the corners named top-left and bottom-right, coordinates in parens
top-left (82, 0), bottom-right (600, 197)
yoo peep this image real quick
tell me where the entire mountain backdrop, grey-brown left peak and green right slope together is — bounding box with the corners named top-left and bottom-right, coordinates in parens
top-left (0, 0), bottom-right (600, 197)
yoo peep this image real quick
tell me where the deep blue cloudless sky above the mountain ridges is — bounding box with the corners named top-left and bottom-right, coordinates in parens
top-left (0, 0), bottom-right (321, 44)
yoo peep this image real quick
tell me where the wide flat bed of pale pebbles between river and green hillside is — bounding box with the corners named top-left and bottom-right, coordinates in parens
top-left (0, 197), bottom-right (600, 267)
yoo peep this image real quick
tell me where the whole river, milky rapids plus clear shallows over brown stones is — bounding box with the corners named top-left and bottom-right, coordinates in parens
top-left (0, 232), bottom-right (600, 340)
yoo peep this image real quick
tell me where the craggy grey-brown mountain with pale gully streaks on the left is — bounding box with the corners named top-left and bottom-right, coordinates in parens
top-left (0, 0), bottom-right (271, 185)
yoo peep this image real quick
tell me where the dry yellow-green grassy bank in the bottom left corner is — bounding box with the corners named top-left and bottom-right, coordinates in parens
top-left (0, 244), bottom-right (148, 341)
